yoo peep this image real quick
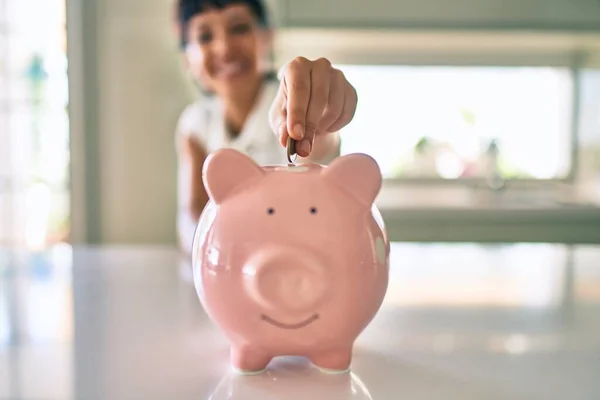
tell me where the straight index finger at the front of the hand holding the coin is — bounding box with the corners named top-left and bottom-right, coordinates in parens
top-left (283, 57), bottom-right (311, 140)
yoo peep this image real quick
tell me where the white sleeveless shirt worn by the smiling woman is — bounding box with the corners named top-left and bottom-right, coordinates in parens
top-left (176, 80), bottom-right (288, 251)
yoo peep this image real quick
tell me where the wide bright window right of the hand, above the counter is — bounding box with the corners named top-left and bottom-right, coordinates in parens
top-left (338, 65), bottom-right (575, 180)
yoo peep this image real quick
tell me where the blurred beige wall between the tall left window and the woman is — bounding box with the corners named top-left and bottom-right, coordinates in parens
top-left (69, 0), bottom-right (193, 243)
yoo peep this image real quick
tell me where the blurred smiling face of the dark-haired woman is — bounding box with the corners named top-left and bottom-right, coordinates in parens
top-left (186, 4), bottom-right (267, 96)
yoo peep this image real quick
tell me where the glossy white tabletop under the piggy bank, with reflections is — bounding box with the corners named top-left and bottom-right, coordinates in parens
top-left (0, 244), bottom-right (600, 400)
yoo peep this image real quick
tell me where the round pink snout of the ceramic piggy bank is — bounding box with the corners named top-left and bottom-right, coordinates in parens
top-left (243, 249), bottom-right (329, 312)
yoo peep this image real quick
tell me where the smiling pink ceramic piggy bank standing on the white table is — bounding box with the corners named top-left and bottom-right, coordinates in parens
top-left (192, 149), bottom-right (390, 374)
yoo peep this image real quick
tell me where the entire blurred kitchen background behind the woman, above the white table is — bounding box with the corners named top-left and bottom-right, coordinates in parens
top-left (0, 0), bottom-right (600, 249)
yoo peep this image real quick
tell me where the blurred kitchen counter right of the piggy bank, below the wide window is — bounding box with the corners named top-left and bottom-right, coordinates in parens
top-left (377, 185), bottom-right (600, 244)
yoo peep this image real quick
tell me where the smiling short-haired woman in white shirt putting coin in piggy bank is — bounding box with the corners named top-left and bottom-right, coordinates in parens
top-left (176, 0), bottom-right (357, 254)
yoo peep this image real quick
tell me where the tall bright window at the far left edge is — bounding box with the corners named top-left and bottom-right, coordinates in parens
top-left (0, 0), bottom-right (70, 248)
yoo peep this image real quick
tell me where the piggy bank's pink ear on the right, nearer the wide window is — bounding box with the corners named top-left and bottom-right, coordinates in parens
top-left (323, 153), bottom-right (383, 207)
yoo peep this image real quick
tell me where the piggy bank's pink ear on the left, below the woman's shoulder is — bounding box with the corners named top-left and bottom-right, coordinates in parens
top-left (202, 148), bottom-right (264, 204)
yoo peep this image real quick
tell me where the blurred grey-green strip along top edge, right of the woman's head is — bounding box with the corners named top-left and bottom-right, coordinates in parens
top-left (279, 0), bottom-right (600, 30)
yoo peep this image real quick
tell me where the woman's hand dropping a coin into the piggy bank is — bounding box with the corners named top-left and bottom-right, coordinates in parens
top-left (269, 57), bottom-right (358, 157)
